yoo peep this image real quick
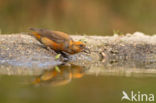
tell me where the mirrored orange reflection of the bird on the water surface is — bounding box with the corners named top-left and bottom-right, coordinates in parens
top-left (33, 64), bottom-right (86, 86)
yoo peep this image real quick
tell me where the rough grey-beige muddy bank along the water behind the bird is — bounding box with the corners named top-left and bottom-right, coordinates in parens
top-left (0, 32), bottom-right (156, 75)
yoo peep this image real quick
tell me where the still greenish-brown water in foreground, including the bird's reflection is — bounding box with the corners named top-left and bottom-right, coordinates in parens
top-left (0, 65), bottom-right (156, 103)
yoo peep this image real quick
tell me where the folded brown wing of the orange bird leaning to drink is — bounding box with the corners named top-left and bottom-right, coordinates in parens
top-left (30, 28), bottom-right (72, 43)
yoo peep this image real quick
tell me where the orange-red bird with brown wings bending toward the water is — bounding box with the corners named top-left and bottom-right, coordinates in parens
top-left (30, 28), bottom-right (89, 54)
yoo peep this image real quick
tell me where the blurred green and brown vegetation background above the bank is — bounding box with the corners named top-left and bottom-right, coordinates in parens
top-left (0, 0), bottom-right (156, 35)
